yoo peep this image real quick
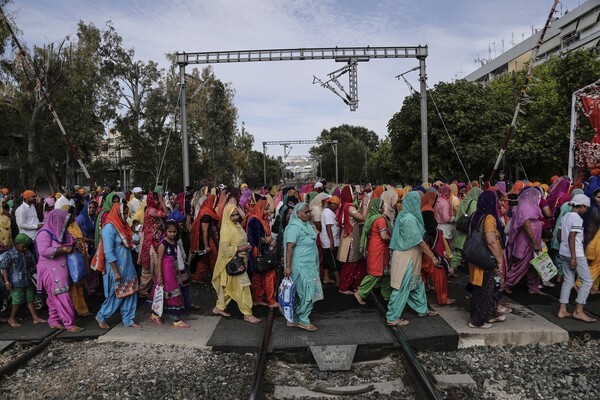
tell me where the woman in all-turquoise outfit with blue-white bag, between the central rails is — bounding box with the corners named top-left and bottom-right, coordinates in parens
top-left (284, 203), bottom-right (323, 332)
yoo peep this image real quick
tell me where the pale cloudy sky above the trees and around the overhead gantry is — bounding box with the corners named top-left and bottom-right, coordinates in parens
top-left (6, 0), bottom-right (585, 156)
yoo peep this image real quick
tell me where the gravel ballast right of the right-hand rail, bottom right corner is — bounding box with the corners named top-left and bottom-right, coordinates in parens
top-left (418, 339), bottom-right (600, 400)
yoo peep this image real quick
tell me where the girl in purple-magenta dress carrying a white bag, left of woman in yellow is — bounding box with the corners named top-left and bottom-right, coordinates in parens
top-left (147, 220), bottom-right (190, 328)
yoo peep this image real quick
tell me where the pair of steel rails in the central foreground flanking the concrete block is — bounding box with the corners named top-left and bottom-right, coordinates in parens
top-left (249, 295), bottom-right (444, 400)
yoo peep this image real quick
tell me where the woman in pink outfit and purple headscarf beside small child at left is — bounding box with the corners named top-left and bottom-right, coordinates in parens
top-left (35, 210), bottom-right (83, 332)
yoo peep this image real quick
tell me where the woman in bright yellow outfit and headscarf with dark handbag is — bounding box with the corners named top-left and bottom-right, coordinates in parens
top-left (212, 204), bottom-right (260, 324)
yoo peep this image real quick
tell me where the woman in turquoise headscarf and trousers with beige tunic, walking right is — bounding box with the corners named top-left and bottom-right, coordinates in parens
top-left (386, 192), bottom-right (440, 326)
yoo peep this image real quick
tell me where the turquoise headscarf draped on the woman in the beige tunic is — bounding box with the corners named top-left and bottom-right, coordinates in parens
top-left (390, 192), bottom-right (425, 251)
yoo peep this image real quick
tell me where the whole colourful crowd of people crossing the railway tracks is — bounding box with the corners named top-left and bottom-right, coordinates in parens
top-left (0, 170), bottom-right (600, 332)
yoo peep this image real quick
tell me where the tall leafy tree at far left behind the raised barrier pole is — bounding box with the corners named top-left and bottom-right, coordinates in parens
top-left (2, 19), bottom-right (112, 190)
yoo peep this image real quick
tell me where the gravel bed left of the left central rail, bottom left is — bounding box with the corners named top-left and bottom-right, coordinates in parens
top-left (0, 340), bottom-right (256, 400)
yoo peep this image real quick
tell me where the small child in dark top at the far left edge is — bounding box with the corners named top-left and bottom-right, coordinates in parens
top-left (0, 233), bottom-right (46, 328)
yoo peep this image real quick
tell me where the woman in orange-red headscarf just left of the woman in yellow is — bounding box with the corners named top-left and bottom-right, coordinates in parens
top-left (190, 194), bottom-right (220, 283)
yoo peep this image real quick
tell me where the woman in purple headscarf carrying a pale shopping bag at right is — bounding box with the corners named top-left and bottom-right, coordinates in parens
top-left (504, 188), bottom-right (543, 294)
